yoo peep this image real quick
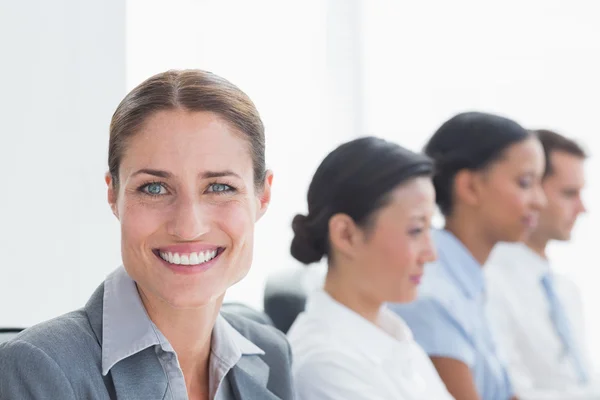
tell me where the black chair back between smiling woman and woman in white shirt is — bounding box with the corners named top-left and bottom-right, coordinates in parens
top-left (264, 266), bottom-right (323, 333)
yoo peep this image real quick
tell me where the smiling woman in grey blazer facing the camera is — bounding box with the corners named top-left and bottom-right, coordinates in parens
top-left (0, 70), bottom-right (292, 399)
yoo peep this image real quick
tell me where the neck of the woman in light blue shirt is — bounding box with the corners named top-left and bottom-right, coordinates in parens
top-left (445, 216), bottom-right (496, 267)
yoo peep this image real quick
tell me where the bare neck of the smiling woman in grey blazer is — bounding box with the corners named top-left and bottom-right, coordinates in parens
top-left (138, 287), bottom-right (223, 398)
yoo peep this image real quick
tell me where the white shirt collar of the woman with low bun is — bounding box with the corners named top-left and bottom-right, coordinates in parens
top-left (306, 290), bottom-right (412, 363)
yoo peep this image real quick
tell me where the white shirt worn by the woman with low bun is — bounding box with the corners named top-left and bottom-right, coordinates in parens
top-left (288, 290), bottom-right (452, 400)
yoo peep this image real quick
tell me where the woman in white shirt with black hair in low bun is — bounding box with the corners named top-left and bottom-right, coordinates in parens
top-left (288, 137), bottom-right (452, 400)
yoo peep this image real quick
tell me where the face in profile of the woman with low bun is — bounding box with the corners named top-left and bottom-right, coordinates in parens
top-left (356, 177), bottom-right (436, 303)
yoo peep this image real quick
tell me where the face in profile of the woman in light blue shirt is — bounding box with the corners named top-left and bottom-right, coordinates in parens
top-left (476, 138), bottom-right (546, 242)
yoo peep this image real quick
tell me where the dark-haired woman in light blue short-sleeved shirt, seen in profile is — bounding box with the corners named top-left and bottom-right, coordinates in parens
top-left (392, 112), bottom-right (545, 400)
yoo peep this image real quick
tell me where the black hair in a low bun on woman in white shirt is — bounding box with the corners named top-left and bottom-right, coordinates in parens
top-left (291, 137), bottom-right (433, 264)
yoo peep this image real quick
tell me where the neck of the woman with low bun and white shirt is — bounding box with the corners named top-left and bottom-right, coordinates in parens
top-left (324, 267), bottom-right (383, 325)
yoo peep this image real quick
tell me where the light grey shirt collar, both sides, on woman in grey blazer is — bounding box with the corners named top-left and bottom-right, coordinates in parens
top-left (102, 267), bottom-right (265, 375)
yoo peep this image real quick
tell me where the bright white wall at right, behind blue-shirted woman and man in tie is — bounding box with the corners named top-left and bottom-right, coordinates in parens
top-left (363, 0), bottom-right (600, 368)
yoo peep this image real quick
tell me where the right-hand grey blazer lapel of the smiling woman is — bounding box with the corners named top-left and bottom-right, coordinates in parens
top-left (227, 355), bottom-right (279, 400)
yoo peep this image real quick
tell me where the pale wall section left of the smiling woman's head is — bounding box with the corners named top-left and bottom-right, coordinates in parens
top-left (0, 0), bottom-right (125, 326)
